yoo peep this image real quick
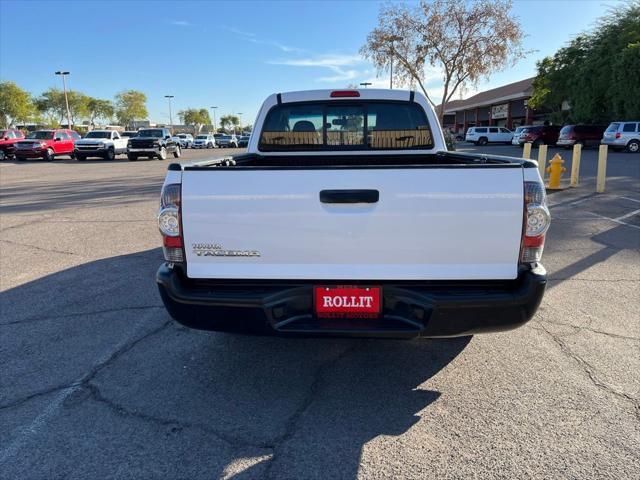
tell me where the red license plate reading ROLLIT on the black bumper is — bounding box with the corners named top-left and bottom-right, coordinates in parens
top-left (315, 285), bottom-right (381, 318)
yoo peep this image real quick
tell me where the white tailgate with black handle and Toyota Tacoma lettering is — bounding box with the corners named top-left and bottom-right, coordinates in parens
top-left (182, 165), bottom-right (523, 280)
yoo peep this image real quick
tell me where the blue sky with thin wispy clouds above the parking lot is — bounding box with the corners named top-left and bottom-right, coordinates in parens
top-left (0, 0), bottom-right (616, 123)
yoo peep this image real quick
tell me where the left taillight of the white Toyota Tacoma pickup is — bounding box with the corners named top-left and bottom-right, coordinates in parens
top-left (158, 183), bottom-right (184, 263)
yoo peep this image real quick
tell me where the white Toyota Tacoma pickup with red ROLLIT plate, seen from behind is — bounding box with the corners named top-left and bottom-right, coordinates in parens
top-left (156, 89), bottom-right (550, 337)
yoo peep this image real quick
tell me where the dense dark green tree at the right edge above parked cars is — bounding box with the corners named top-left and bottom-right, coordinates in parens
top-left (529, 1), bottom-right (640, 123)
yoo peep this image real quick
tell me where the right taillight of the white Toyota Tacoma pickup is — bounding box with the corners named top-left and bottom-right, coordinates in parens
top-left (520, 182), bottom-right (551, 263)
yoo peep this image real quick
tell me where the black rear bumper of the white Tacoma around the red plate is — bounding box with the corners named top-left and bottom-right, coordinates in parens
top-left (156, 264), bottom-right (547, 337)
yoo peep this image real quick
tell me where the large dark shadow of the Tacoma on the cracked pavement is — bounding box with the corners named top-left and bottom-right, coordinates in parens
top-left (0, 249), bottom-right (470, 478)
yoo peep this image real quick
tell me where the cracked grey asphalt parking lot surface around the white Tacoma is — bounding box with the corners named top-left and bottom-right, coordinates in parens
top-left (0, 144), bottom-right (640, 479)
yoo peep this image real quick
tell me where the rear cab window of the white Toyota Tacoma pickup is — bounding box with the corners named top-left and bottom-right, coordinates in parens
top-left (258, 102), bottom-right (433, 151)
